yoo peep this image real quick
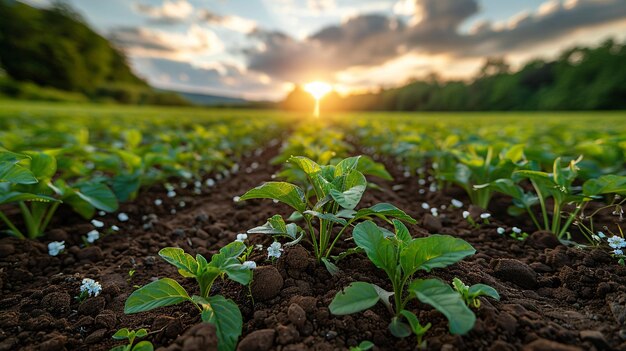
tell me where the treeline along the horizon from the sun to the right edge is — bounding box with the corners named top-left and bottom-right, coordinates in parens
top-left (281, 40), bottom-right (626, 111)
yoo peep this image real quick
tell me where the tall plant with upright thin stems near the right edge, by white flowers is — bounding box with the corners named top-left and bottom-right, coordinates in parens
top-left (475, 157), bottom-right (590, 239)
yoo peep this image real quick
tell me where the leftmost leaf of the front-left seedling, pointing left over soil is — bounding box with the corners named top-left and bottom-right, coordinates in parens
top-left (124, 278), bottom-right (190, 314)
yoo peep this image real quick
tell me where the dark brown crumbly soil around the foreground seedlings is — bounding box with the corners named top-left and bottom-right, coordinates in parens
top-left (0, 144), bottom-right (626, 351)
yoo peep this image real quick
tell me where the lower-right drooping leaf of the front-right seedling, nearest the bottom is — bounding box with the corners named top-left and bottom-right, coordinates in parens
top-left (409, 279), bottom-right (476, 335)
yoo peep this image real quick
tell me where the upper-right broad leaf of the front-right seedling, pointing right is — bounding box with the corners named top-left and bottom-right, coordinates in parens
top-left (400, 235), bottom-right (476, 275)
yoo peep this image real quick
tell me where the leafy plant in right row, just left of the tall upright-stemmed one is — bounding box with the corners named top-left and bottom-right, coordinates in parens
top-left (441, 145), bottom-right (524, 209)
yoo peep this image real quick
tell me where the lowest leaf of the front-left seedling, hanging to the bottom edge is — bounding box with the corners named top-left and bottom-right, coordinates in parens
top-left (202, 295), bottom-right (243, 351)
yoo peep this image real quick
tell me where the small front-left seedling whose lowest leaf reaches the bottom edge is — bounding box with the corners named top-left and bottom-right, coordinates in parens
top-left (124, 241), bottom-right (252, 351)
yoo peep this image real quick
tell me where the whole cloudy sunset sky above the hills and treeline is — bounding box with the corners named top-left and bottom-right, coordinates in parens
top-left (27, 0), bottom-right (626, 99)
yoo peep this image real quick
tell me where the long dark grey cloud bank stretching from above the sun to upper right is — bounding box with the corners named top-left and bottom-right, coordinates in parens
top-left (244, 0), bottom-right (626, 81)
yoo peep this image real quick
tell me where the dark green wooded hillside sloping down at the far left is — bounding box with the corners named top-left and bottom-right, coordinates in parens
top-left (0, 0), bottom-right (188, 105)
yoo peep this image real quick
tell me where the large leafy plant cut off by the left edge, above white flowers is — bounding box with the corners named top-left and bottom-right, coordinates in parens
top-left (0, 150), bottom-right (118, 239)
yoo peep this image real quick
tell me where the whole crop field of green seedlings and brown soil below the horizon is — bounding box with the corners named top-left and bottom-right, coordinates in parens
top-left (0, 102), bottom-right (626, 351)
